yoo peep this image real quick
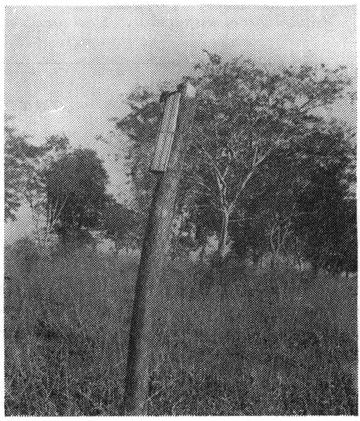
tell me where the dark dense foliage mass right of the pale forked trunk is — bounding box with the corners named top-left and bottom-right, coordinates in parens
top-left (231, 122), bottom-right (356, 269)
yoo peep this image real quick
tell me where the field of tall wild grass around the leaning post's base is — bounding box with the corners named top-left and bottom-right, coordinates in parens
top-left (5, 246), bottom-right (357, 415)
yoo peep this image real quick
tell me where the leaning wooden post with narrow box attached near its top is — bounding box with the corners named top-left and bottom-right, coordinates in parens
top-left (124, 82), bottom-right (196, 415)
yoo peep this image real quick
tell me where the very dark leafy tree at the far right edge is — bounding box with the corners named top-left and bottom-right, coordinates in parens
top-left (295, 122), bottom-right (356, 273)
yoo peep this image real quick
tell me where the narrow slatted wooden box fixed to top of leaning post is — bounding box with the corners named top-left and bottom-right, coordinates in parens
top-left (150, 92), bottom-right (181, 172)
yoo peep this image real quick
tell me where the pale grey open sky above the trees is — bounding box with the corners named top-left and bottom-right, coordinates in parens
top-left (5, 5), bottom-right (356, 242)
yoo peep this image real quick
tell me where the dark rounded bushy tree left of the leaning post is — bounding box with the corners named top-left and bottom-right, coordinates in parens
top-left (43, 149), bottom-right (110, 245)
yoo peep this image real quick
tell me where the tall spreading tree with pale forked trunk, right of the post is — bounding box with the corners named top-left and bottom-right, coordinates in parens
top-left (188, 55), bottom-right (349, 262)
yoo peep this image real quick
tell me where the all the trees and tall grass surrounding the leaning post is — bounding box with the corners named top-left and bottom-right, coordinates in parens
top-left (5, 52), bottom-right (358, 415)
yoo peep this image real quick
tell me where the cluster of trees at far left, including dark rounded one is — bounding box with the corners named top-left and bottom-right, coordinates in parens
top-left (5, 117), bottom-right (110, 248)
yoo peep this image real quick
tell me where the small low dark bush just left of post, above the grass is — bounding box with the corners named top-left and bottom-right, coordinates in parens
top-left (102, 202), bottom-right (140, 255)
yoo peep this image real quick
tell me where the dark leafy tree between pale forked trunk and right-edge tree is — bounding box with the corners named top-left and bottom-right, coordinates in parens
top-left (230, 148), bottom-right (299, 264)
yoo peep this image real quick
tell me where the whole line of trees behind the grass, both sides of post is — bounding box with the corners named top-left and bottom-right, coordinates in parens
top-left (5, 54), bottom-right (357, 273)
